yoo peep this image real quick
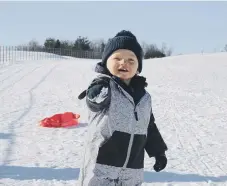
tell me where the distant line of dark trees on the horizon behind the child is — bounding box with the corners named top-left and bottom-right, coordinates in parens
top-left (18, 36), bottom-right (172, 59)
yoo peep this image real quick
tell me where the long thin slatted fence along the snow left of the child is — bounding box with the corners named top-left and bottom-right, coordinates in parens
top-left (0, 46), bottom-right (102, 64)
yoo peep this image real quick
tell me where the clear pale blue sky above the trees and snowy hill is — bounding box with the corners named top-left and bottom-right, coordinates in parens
top-left (0, 1), bottom-right (227, 54)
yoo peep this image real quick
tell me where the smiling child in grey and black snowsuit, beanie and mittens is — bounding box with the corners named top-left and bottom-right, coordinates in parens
top-left (79, 30), bottom-right (167, 186)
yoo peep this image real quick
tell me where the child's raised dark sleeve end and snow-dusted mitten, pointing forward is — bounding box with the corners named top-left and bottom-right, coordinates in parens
top-left (86, 77), bottom-right (110, 112)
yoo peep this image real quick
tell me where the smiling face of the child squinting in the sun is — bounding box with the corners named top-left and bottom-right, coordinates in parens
top-left (106, 49), bottom-right (139, 80)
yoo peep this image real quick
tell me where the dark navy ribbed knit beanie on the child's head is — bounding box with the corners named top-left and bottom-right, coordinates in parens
top-left (102, 30), bottom-right (143, 72)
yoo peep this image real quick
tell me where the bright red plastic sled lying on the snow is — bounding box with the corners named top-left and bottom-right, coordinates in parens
top-left (40, 112), bottom-right (80, 128)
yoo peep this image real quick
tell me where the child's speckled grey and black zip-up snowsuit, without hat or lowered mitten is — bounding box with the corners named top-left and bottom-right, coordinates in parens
top-left (79, 63), bottom-right (167, 186)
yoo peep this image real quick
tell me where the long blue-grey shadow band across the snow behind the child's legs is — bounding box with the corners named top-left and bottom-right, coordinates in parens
top-left (0, 166), bottom-right (227, 183)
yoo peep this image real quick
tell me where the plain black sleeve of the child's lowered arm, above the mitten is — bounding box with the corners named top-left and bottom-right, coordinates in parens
top-left (145, 113), bottom-right (168, 157)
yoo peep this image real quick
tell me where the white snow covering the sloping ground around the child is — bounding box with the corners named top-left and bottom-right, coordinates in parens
top-left (0, 53), bottom-right (227, 186)
